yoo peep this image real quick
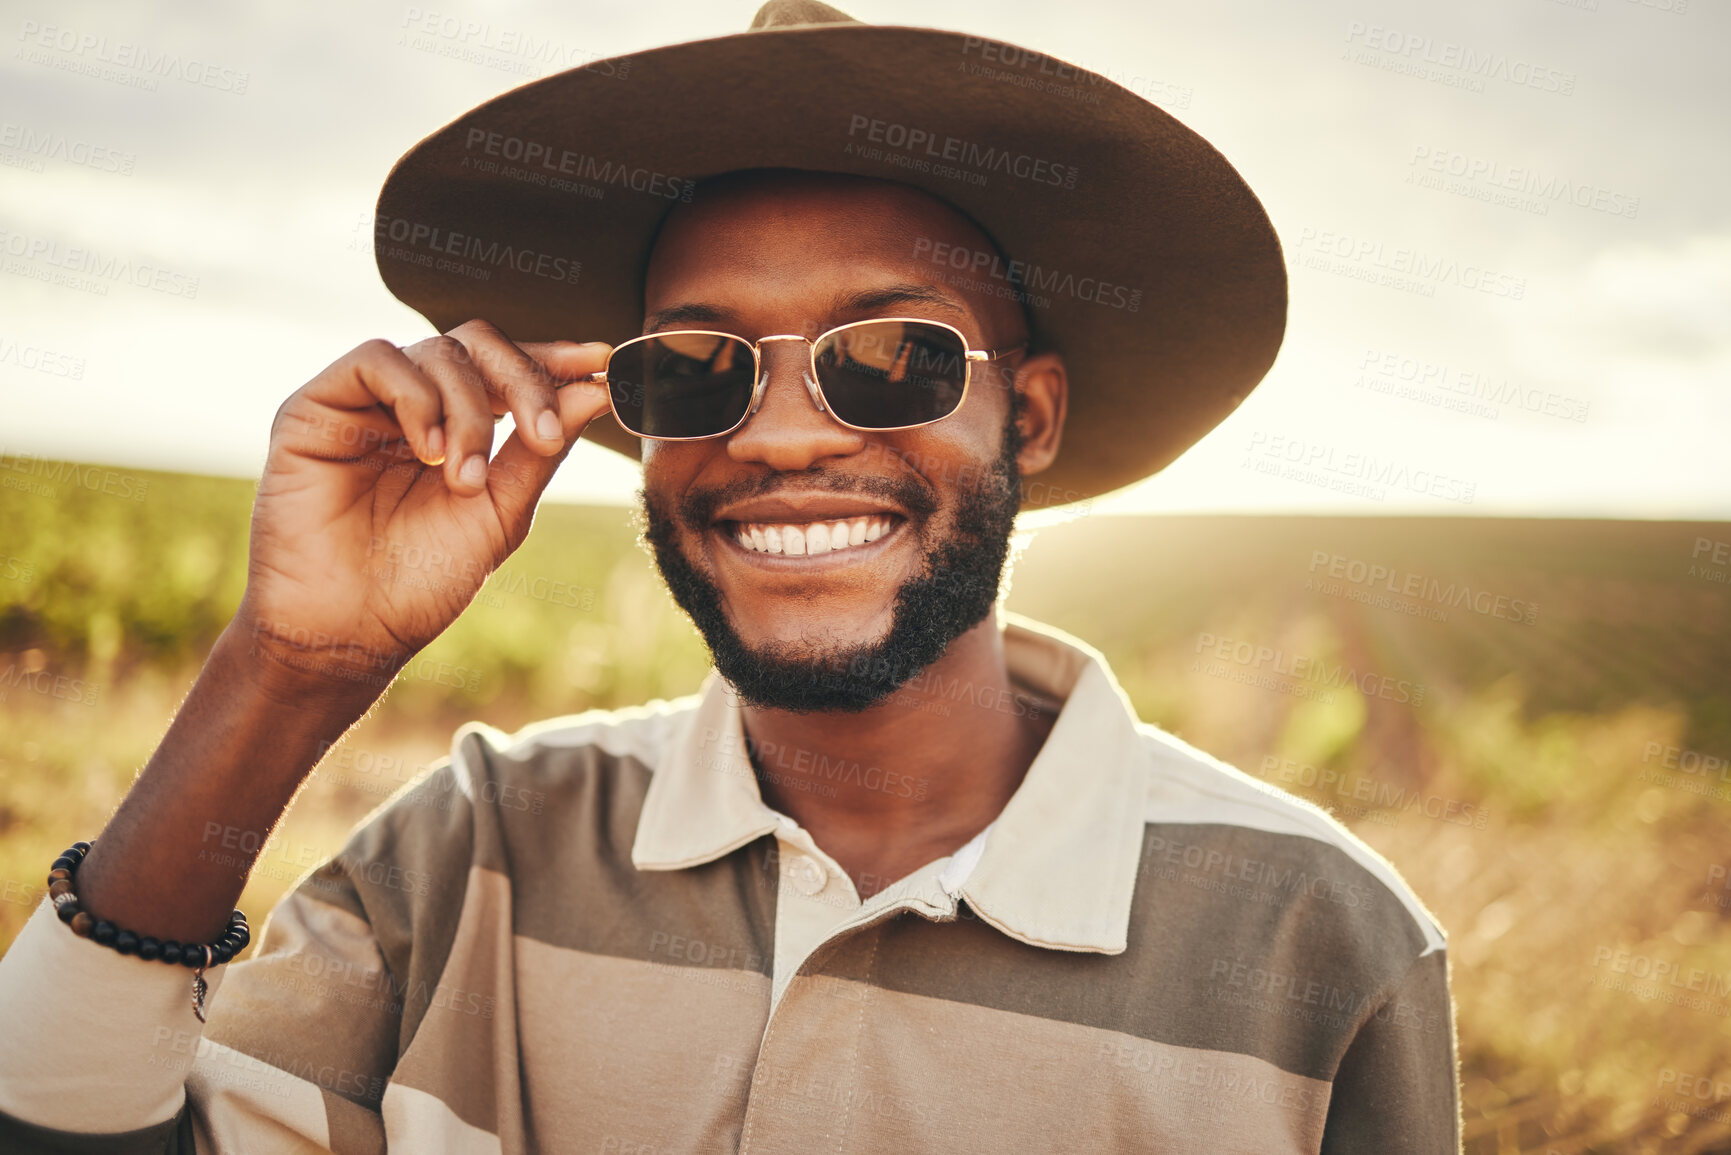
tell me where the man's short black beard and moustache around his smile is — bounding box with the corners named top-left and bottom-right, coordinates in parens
top-left (640, 412), bottom-right (1021, 713)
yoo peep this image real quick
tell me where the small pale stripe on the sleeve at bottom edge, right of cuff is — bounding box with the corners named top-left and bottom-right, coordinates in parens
top-left (187, 1039), bottom-right (331, 1155)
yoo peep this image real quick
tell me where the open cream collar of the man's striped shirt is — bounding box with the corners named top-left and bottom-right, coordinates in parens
top-left (632, 615), bottom-right (1146, 954)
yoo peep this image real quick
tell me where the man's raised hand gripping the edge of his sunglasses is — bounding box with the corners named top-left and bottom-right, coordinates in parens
top-left (235, 320), bottom-right (608, 696)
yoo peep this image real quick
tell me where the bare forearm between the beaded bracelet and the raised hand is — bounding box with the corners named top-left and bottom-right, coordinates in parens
top-left (76, 618), bottom-right (388, 942)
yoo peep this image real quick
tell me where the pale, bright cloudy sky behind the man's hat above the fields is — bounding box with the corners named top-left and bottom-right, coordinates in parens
top-left (0, 0), bottom-right (1731, 518)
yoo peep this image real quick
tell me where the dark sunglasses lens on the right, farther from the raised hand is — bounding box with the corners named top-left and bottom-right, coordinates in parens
top-left (817, 320), bottom-right (968, 429)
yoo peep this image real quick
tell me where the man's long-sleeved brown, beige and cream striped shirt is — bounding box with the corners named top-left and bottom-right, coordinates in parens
top-left (0, 618), bottom-right (1459, 1155)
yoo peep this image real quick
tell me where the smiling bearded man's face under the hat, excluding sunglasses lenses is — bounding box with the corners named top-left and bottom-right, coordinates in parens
top-left (644, 173), bottom-right (1061, 710)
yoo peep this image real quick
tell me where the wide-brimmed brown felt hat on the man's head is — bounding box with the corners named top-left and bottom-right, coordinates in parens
top-left (374, 0), bottom-right (1286, 506)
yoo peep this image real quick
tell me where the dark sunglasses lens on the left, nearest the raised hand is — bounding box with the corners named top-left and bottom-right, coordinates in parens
top-left (608, 332), bottom-right (753, 436)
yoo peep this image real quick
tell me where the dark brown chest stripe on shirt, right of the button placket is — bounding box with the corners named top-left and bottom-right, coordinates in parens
top-left (807, 824), bottom-right (1445, 1081)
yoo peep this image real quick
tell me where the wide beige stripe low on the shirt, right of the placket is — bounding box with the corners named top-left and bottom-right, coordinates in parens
top-left (739, 977), bottom-right (1329, 1155)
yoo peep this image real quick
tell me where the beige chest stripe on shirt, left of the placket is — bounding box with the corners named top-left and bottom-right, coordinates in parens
top-left (518, 937), bottom-right (769, 1153)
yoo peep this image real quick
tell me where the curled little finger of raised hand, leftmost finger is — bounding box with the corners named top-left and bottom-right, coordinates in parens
top-left (270, 341), bottom-right (445, 466)
